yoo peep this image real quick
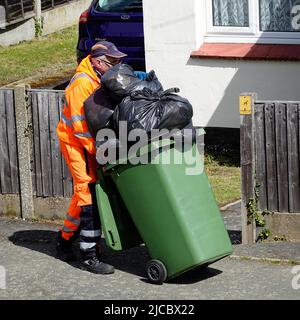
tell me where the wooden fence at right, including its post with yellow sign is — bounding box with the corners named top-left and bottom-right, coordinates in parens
top-left (240, 94), bottom-right (300, 243)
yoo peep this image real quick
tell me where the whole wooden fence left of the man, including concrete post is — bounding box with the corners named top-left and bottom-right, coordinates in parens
top-left (0, 88), bottom-right (73, 218)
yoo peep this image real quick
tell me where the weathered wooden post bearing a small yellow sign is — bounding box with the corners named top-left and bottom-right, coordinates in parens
top-left (239, 93), bottom-right (256, 244)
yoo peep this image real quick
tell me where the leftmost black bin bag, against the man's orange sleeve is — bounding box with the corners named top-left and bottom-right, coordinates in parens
top-left (84, 88), bottom-right (116, 137)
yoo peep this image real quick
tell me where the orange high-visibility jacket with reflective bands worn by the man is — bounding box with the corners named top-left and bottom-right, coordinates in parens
top-left (56, 56), bottom-right (100, 154)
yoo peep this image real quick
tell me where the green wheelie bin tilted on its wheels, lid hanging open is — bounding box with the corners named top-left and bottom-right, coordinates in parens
top-left (96, 131), bottom-right (232, 283)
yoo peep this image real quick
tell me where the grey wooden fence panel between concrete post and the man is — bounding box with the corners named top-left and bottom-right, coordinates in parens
top-left (28, 90), bottom-right (72, 197)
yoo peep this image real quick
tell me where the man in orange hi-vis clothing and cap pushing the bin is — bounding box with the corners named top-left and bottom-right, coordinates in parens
top-left (56, 41), bottom-right (126, 274)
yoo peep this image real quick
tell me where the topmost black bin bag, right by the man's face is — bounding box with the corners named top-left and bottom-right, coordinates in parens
top-left (101, 64), bottom-right (163, 103)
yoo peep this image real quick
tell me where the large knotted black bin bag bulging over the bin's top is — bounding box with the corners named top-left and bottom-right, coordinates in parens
top-left (113, 88), bottom-right (193, 133)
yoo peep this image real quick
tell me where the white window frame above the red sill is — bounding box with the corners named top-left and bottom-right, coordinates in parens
top-left (205, 0), bottom-right (300, 44)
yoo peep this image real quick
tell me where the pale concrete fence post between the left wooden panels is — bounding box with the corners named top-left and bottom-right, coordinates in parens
top-left (14, 84), bottom-right (34, 219)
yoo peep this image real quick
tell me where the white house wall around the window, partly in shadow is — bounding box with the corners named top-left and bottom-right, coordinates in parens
top-left (144, 0), bottom-right (300, 128)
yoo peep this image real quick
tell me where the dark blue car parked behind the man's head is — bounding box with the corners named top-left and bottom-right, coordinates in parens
top-left (77, 0), bottom-right (145, 71)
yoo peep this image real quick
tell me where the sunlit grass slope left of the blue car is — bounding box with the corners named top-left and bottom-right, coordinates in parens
top-left (0, 25), bottom-right (78, 86)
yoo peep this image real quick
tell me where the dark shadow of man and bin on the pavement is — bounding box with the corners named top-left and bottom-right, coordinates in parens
top-left (9, 230), bottom-right (221, 284)
